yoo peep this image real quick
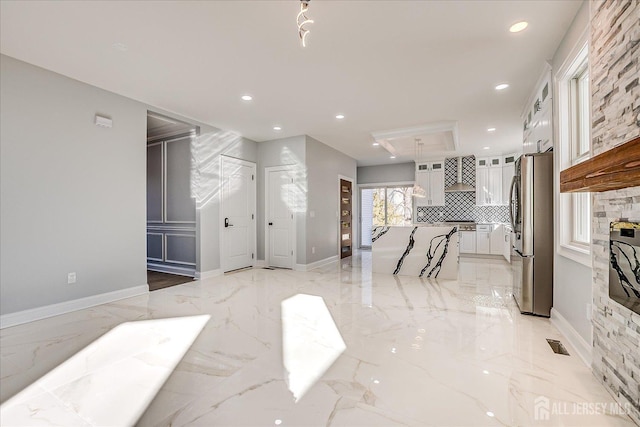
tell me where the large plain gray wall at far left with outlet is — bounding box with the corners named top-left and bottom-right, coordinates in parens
top-left (0, 55), bottom-right (147, 314)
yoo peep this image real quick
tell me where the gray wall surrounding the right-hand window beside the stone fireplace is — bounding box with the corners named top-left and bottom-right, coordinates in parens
top-left (551, 2), bottom-right (592, 343)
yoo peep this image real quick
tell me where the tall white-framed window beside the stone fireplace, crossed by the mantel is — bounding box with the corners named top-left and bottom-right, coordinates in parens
top-left (556, 43), bottom-right (591, 266)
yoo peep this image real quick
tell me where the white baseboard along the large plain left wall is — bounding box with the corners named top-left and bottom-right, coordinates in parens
top-left (0, 284), bottom-right (149, 329)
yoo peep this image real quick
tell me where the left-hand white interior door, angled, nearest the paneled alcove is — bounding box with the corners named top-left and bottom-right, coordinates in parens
top-left (220, 156), bottom-right (256, 271)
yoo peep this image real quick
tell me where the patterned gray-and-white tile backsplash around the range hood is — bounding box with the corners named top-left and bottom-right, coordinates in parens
top-left (416, 156), bottom-right (509, 223)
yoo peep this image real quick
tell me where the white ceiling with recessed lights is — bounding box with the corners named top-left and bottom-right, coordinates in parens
top-left (0, 0), bottom-right (582, 165)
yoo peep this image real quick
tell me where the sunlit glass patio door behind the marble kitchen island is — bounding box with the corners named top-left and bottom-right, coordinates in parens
top-left (360, 186), bottom-right (413, 247)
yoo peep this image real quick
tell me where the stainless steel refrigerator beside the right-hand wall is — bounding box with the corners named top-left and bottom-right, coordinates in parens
top-left (509, 152), bottom-right (553, 317)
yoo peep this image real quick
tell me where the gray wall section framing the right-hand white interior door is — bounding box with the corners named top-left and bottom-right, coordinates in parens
top-left (257, 135), bottom-right (307, 264)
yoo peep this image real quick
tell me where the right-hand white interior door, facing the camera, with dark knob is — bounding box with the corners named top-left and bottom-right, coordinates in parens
top-left (265, 168), bottom-right (295, 268)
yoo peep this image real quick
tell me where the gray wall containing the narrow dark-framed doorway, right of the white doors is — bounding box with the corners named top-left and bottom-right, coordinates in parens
top-left (306, 136), bottom-right (358, 264)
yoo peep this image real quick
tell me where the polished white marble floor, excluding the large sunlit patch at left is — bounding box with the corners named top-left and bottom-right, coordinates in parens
top-left (0, 252), bottom-right (634, 426)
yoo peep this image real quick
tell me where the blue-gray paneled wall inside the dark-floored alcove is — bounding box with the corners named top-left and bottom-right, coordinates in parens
top-left (147, 135), bottom-right (196, 275)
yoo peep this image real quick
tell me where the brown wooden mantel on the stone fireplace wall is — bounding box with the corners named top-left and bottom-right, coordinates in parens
top-left (560, 137), bottom-right (640, 193)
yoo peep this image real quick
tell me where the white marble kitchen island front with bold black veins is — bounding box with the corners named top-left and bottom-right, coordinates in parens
top-left (371, 225), bottom-right (458, 279)
